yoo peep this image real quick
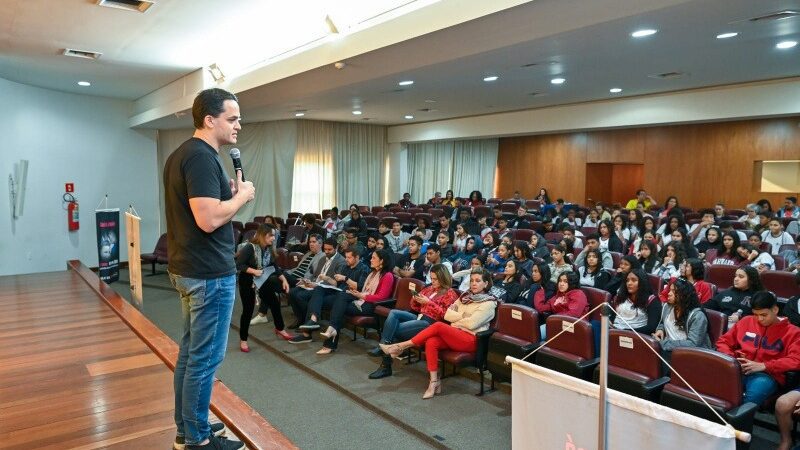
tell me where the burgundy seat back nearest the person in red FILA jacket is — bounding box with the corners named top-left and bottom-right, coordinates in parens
top-left (664, 347), bottom-right (744, 411)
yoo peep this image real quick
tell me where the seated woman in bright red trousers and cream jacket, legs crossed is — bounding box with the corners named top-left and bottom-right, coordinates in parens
top-left (380, 268), bottom-right (497, 399)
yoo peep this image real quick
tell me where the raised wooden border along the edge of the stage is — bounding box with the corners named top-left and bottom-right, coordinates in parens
top-left (67, 260), bottom-right (297, 450)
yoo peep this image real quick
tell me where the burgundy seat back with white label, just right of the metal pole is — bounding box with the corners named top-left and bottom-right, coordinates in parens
top-left (608, 330), bottom-right (663, 380)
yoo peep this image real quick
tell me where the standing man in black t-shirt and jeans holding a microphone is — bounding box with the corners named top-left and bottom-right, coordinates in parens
top-left (164, 89), bottom-right (255, 450)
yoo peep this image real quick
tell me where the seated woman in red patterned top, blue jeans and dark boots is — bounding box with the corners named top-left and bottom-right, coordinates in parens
top-left (369, 264), bottom-right (458, 380)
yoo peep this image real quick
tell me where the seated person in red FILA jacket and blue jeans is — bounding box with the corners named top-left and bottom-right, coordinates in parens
top-left (717, 291), bottom-right (800, 405)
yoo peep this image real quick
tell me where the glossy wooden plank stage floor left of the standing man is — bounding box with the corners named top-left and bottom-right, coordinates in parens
top-left (0, 271), bottom-right (180, 449)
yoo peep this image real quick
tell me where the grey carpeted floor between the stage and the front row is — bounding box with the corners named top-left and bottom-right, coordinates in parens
top-left (112, 270), bottom-right (778, 450)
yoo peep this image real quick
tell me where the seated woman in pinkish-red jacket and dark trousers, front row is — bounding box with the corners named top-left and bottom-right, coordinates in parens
top-left (317, 249), bottom-right (394, 355)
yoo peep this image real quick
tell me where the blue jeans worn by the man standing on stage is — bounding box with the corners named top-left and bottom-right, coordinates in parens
top-left (169, 273), bottom-right (236, 445)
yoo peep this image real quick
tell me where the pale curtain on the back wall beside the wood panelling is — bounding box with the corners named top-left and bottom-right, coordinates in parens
top-left (408, 139), bottom-right (498, 203)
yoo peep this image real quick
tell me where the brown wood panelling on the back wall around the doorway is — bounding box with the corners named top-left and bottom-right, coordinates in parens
top-left (497, 117), bottom-right (800, 208)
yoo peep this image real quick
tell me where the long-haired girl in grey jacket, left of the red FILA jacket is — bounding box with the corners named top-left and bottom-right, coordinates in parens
top-left (653, 278), bottom-right (713, 354)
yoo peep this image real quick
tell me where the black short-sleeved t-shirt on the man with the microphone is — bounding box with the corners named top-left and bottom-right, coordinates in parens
top-left (164, 138), bottom-right (236, 280)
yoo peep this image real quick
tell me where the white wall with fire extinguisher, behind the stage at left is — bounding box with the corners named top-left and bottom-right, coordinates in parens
top-left (0, 78), bottom-right (159, 275)
